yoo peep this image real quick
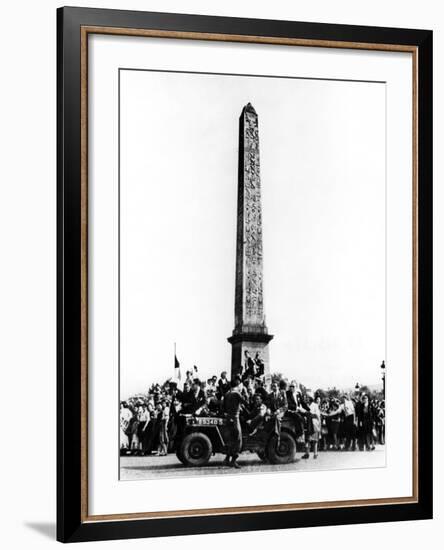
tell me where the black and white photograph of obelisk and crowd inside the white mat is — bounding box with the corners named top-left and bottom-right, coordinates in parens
top-left (119, 68), bottom-right (390, 481)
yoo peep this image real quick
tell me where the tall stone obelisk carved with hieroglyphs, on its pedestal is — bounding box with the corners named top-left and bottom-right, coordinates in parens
top-left (228, 103), bottom-right (273, 377)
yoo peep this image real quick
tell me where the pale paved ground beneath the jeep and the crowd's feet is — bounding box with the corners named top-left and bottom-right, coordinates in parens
top-left (120, 445), bottom-right (385, 480)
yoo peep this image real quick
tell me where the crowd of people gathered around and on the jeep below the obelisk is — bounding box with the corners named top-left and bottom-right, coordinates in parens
top-left (120, 357), bottom-right (385, 467)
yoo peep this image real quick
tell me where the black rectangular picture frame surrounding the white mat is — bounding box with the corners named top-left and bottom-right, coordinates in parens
top-left (57, 7), bottom-right (433, 542)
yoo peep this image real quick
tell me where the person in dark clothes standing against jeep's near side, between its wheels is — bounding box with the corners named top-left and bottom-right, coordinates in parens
top-left (223, 376), bottom-right (246, 468)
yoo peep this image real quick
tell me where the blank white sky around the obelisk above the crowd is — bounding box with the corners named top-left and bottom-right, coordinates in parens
top-left (120, 70), bottom-right (385, 397)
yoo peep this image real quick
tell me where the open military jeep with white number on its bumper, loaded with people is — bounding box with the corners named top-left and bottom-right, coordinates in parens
top-left (175, 414), bottom-right (298, 466)
